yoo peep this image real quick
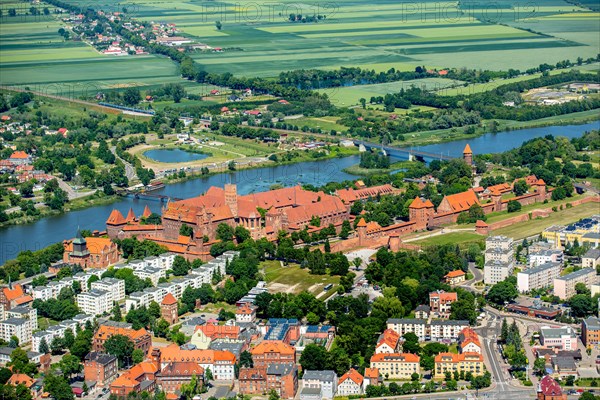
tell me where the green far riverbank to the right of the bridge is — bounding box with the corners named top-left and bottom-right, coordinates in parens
top-left (390, 110), bottom-right (600, 148)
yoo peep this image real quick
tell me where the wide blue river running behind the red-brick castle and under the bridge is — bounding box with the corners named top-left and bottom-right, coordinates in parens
top-left (0, 122), bottom-right (600, 264)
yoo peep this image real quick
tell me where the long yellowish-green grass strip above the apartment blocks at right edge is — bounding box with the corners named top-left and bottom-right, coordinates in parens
top-left (493, 203), bottom-right (598, 239)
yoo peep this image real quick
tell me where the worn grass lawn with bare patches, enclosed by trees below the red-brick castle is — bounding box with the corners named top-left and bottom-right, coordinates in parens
top-left (261, 261), bottom-right (340, 295)
